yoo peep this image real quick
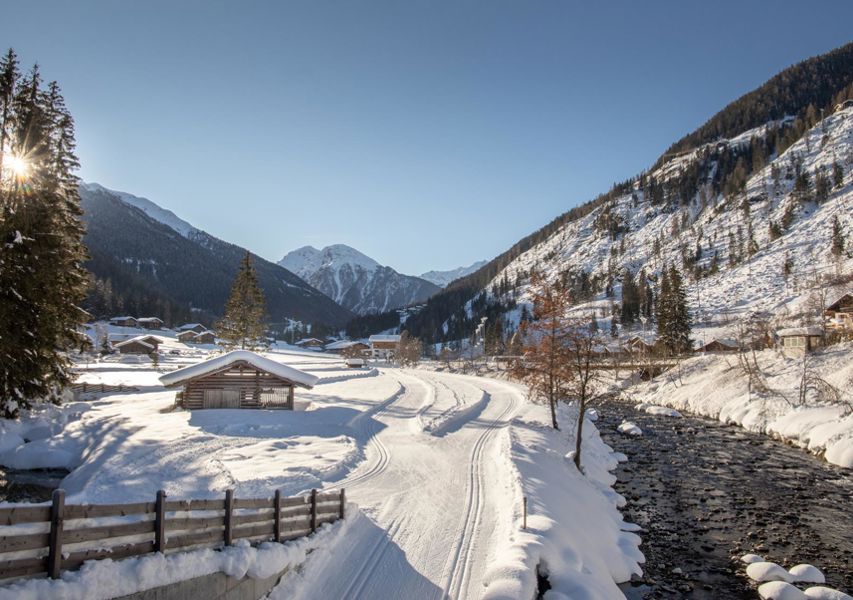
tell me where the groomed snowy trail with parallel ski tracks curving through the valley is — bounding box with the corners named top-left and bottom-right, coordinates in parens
top-left (290, 370), bottom-right (522, 598)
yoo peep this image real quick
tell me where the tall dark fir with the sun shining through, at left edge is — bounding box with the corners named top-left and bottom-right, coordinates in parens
top-left (0, 50), bottom-right (88, 418)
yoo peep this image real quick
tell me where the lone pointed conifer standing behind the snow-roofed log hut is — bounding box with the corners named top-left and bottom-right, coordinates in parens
top-left (216, 252), bottom-right (266, 349)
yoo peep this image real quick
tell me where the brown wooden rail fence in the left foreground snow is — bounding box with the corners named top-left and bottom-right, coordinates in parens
top-left (0, 490), bottom-right (346, 580)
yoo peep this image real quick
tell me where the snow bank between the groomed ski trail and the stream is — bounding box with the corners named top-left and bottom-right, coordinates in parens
top-left (482, 404), bottom-right (645, 600)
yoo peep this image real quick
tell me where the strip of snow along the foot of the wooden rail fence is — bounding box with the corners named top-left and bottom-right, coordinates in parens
top-left (0, 505), bottom-right (358, 600)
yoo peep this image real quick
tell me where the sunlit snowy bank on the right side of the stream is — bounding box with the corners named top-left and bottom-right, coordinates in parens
top-left (629, 342), bottom-right (853, 468)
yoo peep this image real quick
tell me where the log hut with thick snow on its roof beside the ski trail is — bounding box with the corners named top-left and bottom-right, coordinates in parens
top-left (160, 350), bottom-right (317, 410)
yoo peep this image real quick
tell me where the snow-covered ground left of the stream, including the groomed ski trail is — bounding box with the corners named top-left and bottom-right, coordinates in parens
top-left (0, 349), bottom-right (642, 599)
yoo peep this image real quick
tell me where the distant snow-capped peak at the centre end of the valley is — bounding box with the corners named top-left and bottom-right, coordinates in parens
top-left (278, 244), bottom-right (440, 314)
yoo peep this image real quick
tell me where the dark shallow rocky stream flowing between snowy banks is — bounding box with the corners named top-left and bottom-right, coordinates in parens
top-left (597, 402), bottom-right (853, 599)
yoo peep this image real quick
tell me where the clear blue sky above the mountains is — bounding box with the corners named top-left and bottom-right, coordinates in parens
top-left (0, 0), bottom-right (853, 274)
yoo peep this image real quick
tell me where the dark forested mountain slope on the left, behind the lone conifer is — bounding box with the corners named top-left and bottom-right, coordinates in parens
top-left (80, 184), bottom-right (353, 325)
